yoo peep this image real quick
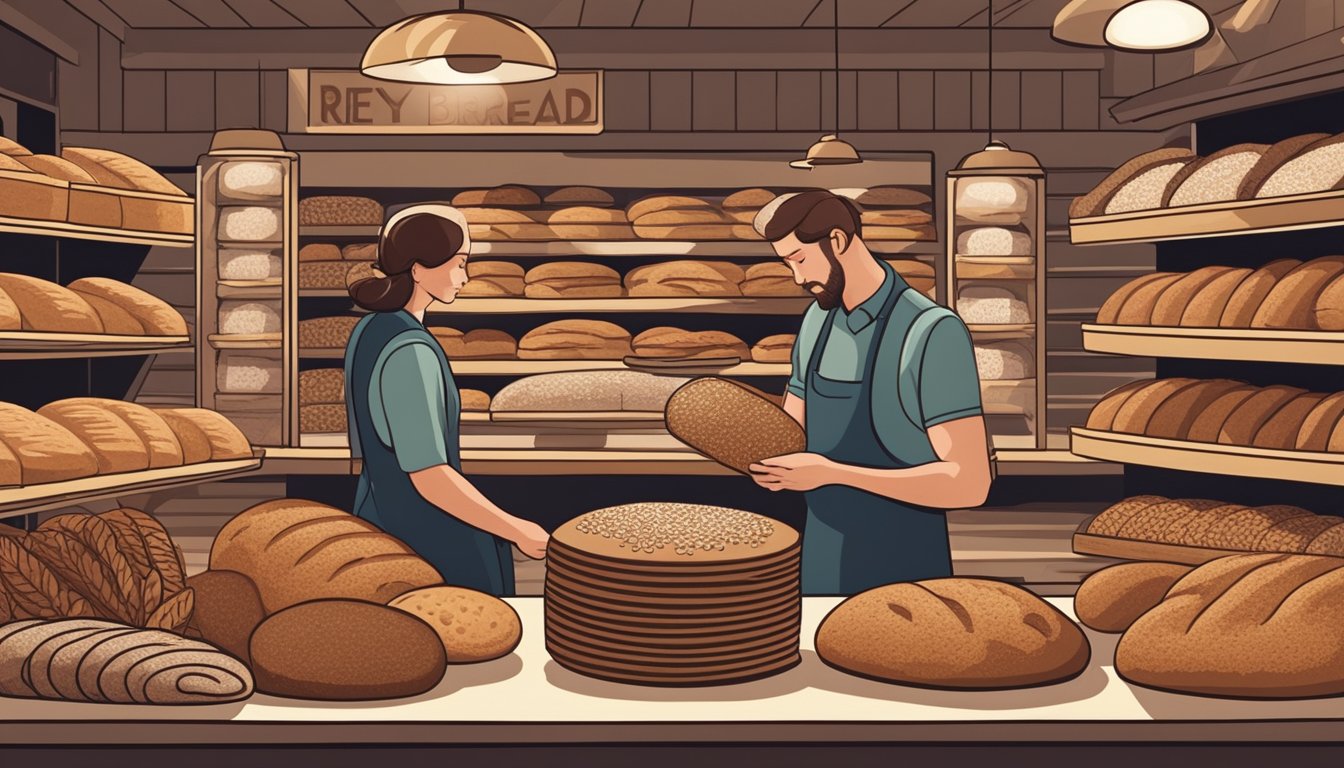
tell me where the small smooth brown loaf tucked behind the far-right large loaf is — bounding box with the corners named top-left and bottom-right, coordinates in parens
top-left (1074, 562), bottom-right (1191, 632)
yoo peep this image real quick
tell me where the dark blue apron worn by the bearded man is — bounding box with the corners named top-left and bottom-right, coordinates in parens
top-left (802, 277), bottom-right (952, 596)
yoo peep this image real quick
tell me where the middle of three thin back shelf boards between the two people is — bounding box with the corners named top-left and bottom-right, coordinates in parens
top-left (429, 296), bottom-right (813, 315)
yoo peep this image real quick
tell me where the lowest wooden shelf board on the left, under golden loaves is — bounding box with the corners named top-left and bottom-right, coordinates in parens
top-left (0, 455), bottom-right (262, 518)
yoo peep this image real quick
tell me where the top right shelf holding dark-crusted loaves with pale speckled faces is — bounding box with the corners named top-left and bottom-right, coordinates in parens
top-left (1068, 133), bottom-right (1344, 245)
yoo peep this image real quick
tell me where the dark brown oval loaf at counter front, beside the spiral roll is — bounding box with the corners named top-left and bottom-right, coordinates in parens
top-left (249, 600), bottom-right (448, 701)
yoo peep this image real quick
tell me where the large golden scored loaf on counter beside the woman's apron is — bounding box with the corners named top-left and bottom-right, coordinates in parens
top-left (210, 499), bottom-right (442, 613)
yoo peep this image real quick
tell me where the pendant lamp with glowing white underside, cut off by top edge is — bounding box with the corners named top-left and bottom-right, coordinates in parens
top-left (1050, 0), bottom-right (1214, 52)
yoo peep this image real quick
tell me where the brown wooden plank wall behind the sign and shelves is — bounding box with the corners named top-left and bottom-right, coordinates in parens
top-left (52, 23), bottom-right (1187, 432)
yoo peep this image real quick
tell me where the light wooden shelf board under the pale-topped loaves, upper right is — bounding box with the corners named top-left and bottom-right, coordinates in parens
top-left (1068, 190), bottom-right (1344, 245)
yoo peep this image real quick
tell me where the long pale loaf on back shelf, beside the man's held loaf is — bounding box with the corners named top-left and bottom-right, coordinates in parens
top-left (489, 370), bottom-right (688, 413)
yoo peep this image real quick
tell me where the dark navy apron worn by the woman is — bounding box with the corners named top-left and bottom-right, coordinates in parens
top-left (345, 312), bottom-right (513, 596)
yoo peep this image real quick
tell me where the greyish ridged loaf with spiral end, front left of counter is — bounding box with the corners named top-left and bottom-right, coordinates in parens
top-left (0, 619), bottom-right (253, 705)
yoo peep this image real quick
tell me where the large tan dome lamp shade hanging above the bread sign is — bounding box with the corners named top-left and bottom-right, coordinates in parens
top-left (359, 11), bottom-right (556, 85)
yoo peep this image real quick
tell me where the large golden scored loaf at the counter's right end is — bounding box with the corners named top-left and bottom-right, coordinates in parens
top-left (1116, 554), bottom-right (1344, 698)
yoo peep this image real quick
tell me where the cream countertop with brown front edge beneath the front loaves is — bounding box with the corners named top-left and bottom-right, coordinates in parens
top-left (0, 597), bottom-right (1344, 744)
